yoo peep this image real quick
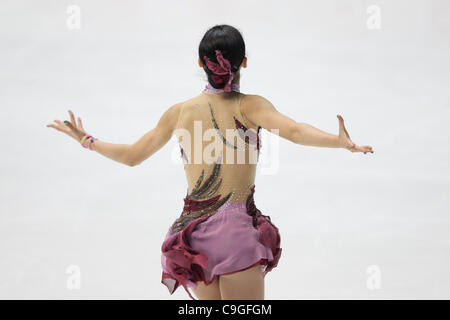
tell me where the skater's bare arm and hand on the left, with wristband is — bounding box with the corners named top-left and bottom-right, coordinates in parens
top-left (47, 103), bottom-right (181, 166)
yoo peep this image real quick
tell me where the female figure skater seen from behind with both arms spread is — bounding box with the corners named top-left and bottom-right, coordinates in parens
top-left (47, 25), bottom-right (373, 300)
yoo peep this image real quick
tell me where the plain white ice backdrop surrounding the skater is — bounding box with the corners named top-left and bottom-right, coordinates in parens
top-left (0, 0), bottom-right (450, 299)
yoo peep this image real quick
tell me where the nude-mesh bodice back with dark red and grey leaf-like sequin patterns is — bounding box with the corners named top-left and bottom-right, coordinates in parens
top-left (172, 92), bottom-right (261, 232)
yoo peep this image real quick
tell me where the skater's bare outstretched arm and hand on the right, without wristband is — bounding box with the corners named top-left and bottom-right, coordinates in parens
top-left (241, 95), bottom-right (373, 154)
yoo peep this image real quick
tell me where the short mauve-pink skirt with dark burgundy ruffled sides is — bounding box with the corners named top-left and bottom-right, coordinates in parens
top-left (161, 202), bottom-right (281, 300)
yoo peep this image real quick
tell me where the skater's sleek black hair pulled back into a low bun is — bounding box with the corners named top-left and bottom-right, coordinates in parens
top-left (198, 24), bottom-right (245, 89)
